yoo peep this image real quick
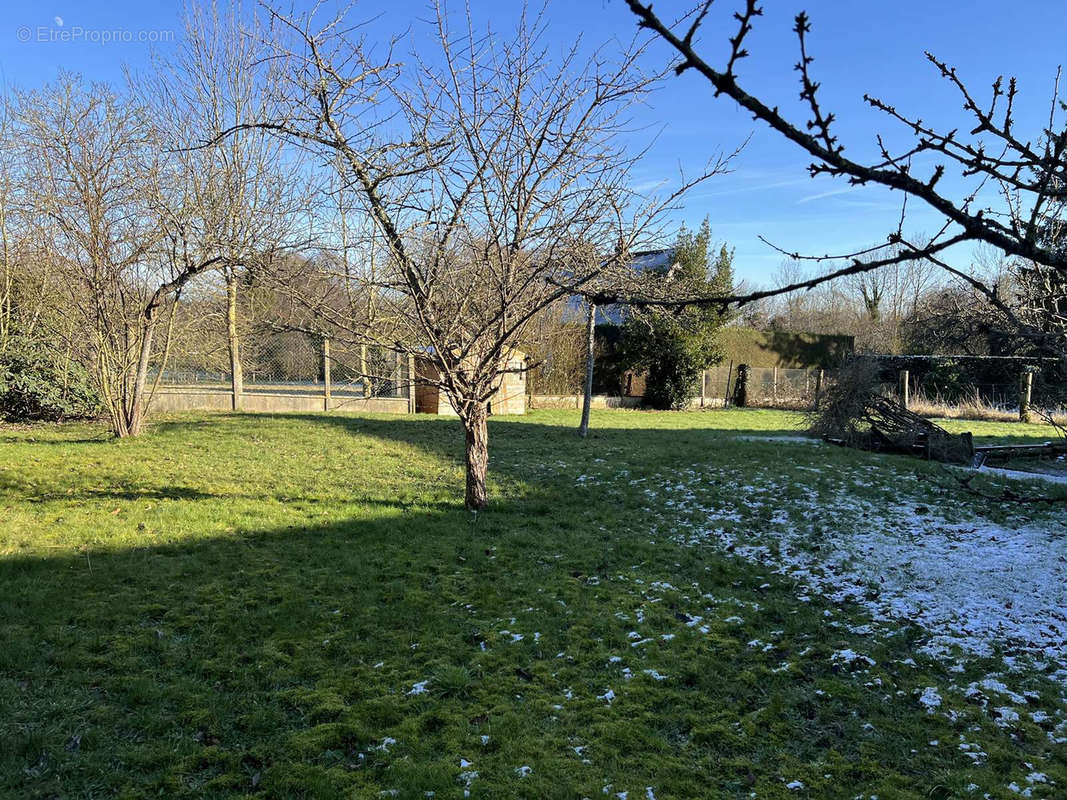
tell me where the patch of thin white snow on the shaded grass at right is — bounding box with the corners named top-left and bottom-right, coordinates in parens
top-left (641, 456), bottom-right (1067, 683)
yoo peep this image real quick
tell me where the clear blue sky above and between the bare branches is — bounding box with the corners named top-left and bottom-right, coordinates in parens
top-left (0, 0), bottom-right (1067, 283)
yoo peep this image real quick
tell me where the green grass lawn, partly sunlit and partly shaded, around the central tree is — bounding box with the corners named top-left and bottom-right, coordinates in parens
top-left (0, 411), bottom-right (1067, 800)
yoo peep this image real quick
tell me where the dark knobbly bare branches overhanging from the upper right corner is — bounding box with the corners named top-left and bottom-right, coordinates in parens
top-left (614, 0), bottom-right (1067, 354)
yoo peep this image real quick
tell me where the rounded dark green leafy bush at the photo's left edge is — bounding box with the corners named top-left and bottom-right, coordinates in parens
top-left (0, 337), bottom-right (100, 422)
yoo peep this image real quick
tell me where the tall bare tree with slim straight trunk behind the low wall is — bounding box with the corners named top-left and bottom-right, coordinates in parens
top-left (139, 3), bottom-right (312, 407)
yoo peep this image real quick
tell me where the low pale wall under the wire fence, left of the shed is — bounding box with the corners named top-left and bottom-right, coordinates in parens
top-left (153, 386), bottom-right (411, 414)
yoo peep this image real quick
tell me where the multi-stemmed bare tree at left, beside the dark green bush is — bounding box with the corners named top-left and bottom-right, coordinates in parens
top-left (17, 75), bottom-right (169, 436)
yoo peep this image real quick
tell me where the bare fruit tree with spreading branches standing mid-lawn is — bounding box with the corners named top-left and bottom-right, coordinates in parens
top-left (206, 6), bottom-right (723, 510)
